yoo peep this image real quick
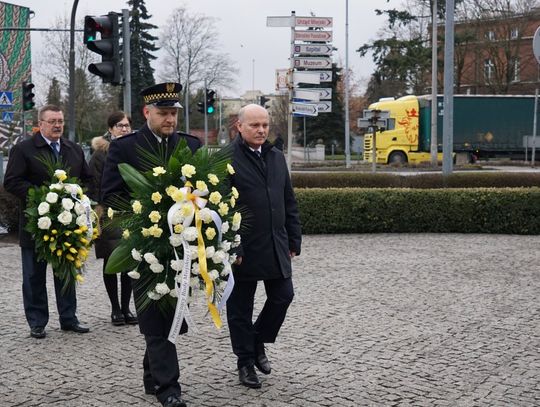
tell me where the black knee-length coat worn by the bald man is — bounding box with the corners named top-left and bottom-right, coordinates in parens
top-left (231, 135), bottom-right (302, 281)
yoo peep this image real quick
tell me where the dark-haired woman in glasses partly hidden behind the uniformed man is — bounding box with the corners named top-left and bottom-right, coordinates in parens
top-left (89, 111), bottom-right (137, 325)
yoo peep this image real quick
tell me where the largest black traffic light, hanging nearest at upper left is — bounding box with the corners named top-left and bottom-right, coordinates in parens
top-left (83, 12), bottom-right (121, 85)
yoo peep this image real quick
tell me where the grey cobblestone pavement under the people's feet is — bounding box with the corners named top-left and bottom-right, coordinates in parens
top-left (0, 234), bottom-right (540, 407)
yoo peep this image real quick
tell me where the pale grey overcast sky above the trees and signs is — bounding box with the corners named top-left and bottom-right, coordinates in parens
top-left (8, 0), bottom-right (392, 96)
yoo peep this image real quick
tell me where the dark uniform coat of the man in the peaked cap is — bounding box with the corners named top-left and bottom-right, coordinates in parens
top-left (101, 124), bottom-right (201, 337)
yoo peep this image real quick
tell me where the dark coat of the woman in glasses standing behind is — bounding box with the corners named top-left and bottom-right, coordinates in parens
top-left (88, 134), bottom-right (121, 259)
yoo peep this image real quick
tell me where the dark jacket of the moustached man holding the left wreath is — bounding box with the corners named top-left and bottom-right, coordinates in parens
top-left (4, 133), bottom-right (92, 248)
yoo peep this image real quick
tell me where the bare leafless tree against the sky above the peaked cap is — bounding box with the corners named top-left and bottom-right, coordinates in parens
top-left (160, 6), bottom-right (237, 97)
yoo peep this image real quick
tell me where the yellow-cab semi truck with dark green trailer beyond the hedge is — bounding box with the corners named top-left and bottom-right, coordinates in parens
top-left (363, 95), bottom-right (540, 164)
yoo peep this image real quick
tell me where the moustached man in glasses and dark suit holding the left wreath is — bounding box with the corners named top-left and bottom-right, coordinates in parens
top-left (4, 105), bottom-right (92, 338)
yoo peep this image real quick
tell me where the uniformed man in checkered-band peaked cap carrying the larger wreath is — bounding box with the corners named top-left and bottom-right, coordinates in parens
top-left (101, 83), bottom-right (201, 407)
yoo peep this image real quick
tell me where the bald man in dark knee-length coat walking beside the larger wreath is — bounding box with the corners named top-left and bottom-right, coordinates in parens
top-left (227, 104), bottom-right (302, 388)
